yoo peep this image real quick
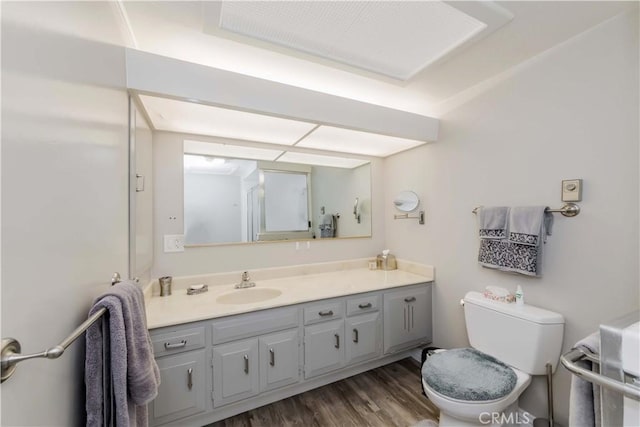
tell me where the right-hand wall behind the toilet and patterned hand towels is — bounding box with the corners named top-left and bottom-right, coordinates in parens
top-left (384, 12), bottom-right (639, 425)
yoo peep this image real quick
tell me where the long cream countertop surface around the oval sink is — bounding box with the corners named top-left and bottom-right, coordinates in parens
top-left (147, 268), bottom-right (433, 329)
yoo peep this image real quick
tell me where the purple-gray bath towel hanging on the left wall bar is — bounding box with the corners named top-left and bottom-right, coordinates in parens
top-left (85, 282), bottom-right (160, 427)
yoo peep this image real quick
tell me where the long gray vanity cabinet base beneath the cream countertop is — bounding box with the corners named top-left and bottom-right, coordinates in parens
top-left (149, 283), bottom-right (431, 427)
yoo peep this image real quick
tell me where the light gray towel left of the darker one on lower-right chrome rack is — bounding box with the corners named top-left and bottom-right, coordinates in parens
top-left (569, 332), bottom-right (601, 427)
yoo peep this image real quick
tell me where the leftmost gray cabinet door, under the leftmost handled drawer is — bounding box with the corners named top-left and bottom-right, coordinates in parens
top-left (150, 350), bottom-right (207, 425)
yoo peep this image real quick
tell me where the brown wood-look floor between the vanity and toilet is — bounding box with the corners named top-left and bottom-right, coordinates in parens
top-left (209, 358), bottom-right (438, 427)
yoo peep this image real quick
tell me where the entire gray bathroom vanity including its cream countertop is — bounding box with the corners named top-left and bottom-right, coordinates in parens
top-left (147, 269), bottom-right (433, 426)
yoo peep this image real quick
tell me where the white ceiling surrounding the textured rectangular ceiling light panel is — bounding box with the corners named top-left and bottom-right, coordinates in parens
top-left (116, 1), bottom-right (637, 117)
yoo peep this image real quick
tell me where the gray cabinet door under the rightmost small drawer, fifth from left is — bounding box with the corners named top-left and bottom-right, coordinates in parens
top-left (344, 313), bottom-right (382, 364)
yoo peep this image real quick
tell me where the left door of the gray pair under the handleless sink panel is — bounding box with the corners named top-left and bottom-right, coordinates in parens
top-left (213, 339), bottom-right (259, 407)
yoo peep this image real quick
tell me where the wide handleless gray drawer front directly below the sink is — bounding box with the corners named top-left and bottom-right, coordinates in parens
top-left (211, 307), bottom-right (300, 345)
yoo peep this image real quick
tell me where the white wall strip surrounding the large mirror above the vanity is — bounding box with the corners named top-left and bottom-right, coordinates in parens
top-left (152, 132), bottom-right (384, 277)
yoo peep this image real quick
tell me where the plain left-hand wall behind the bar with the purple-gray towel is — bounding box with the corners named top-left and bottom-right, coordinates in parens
top-left (1, 2), bottom-right (128, 426)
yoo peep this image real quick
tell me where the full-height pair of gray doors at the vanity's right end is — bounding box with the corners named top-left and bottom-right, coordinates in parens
top-left (383, 286), bottom-right (431, 354)
